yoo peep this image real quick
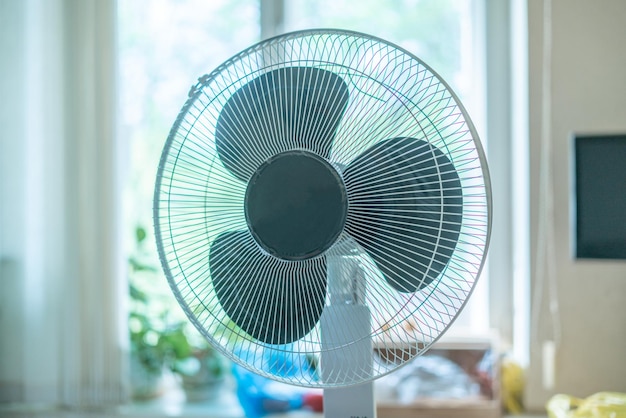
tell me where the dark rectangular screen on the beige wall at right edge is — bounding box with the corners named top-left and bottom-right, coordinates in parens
top-left (574, 134), bottom-right (626, 259)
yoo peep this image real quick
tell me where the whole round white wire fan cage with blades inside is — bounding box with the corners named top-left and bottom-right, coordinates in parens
top-left (154, 30), bottom-right (491, 387)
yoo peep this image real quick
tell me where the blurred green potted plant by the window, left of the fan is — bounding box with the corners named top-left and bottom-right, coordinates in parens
top-left (129, 227), bottom-right (226, 401)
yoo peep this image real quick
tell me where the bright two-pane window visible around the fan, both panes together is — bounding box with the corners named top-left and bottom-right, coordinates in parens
top-left (119, 0), bottom-right (489, 406)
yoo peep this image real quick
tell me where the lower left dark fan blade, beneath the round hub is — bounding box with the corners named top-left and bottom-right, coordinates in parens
top-left (209, 231), bottom-right (326, 344)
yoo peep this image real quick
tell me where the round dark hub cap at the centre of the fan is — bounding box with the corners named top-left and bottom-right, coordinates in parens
top-left (245, 150), bottom-right (348, 260)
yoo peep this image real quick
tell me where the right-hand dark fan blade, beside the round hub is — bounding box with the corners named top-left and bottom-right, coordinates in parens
top-left (344, 138), bottom-right (463, 292)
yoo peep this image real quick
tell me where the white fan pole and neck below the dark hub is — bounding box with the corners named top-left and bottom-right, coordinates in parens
top-left (320, 254), bottom-right (376, 418)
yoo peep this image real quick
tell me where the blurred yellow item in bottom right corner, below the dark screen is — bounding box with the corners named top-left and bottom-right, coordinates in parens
top-left (546, 392), bottom-right (626, 418)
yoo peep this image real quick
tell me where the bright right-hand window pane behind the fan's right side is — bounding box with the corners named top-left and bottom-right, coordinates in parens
top-left (284, 0), bottom-right (489, 337)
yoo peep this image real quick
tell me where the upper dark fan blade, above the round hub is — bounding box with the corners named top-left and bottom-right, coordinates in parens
top-left (215, 67), bottom-right (348, 181)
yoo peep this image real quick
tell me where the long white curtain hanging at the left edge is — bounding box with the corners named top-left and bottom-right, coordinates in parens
top-left (0, 0), bottom-right (127, 407)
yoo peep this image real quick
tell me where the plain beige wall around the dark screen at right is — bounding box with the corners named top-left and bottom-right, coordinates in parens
top-left (526, 0), bottom-right (626, 410)
